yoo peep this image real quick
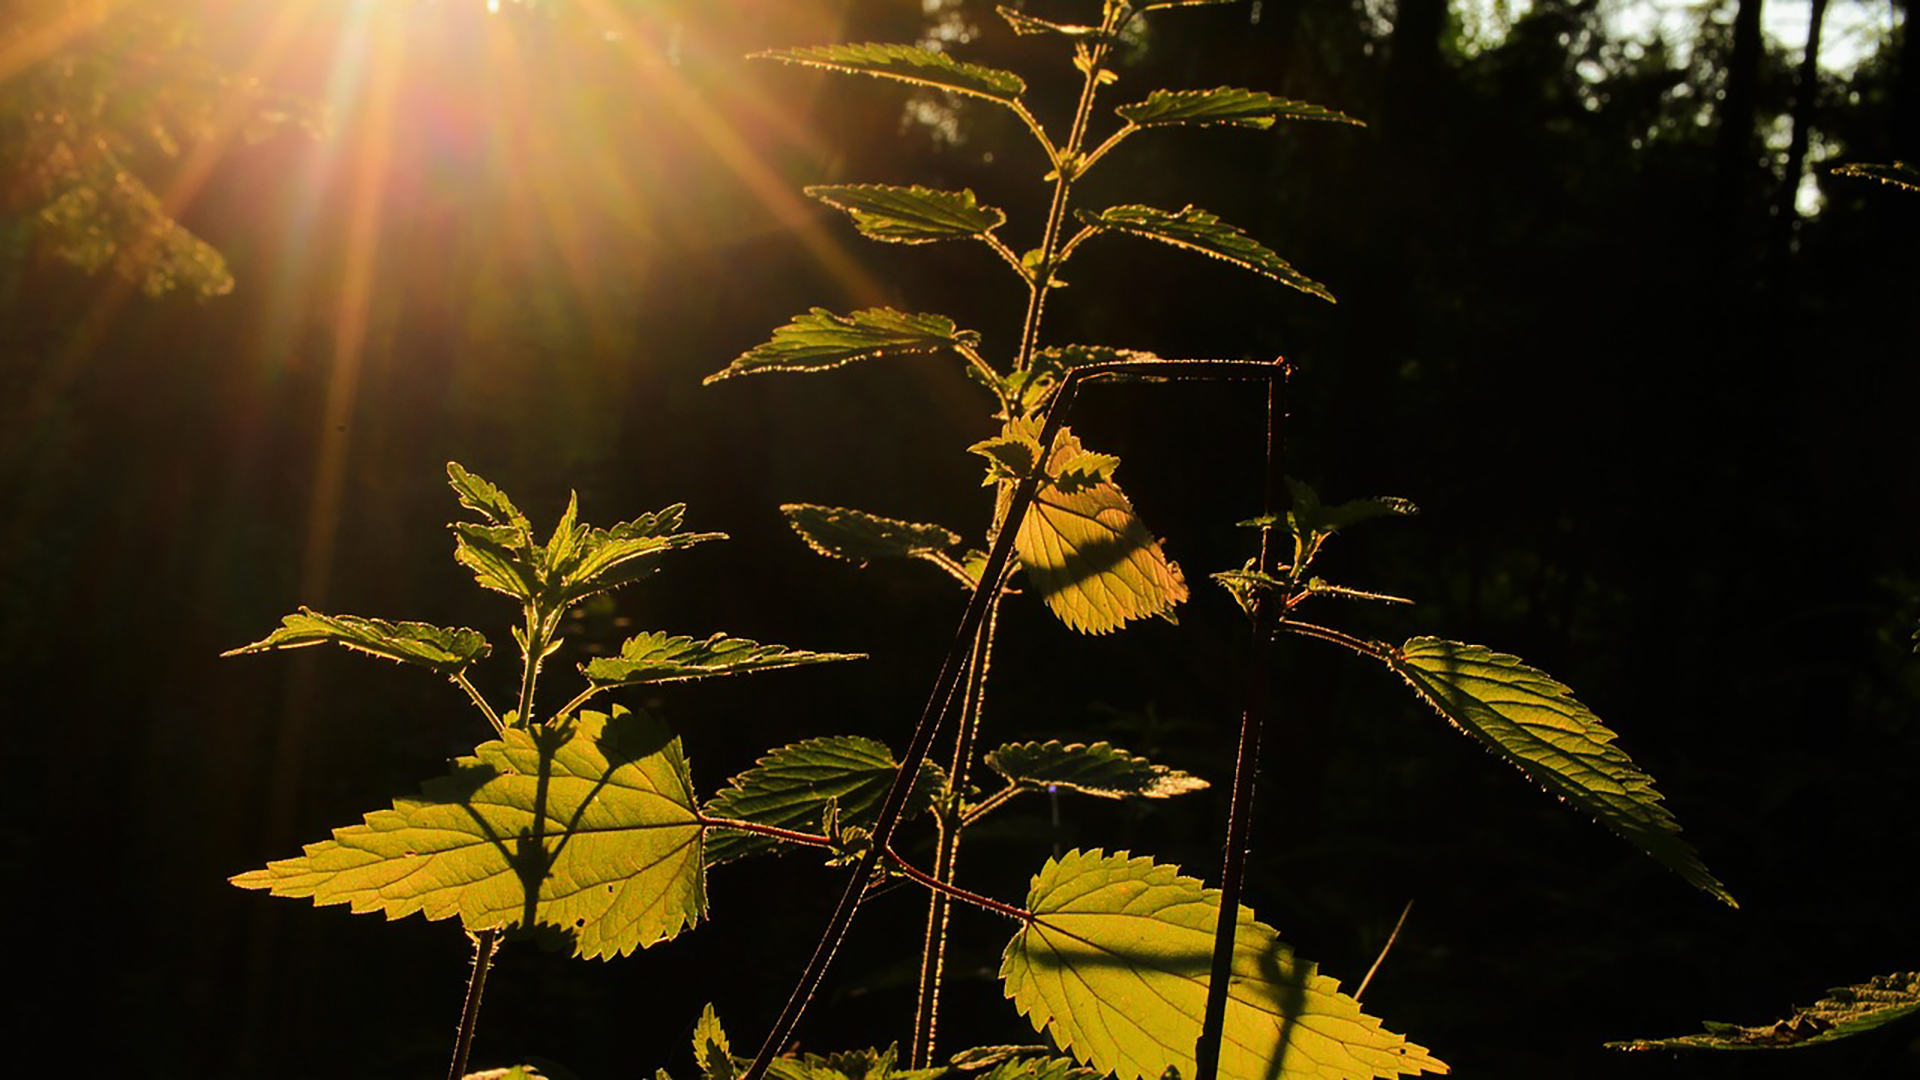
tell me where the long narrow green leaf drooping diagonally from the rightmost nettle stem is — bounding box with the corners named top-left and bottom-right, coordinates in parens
top-left (1386, 638), bottom-right (1740, 907)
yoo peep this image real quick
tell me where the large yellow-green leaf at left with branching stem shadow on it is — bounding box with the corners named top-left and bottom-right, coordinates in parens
top-left (232, 707), bottom-right (707, 957)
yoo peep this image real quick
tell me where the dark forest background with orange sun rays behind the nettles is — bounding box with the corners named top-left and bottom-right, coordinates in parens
top-left (0, 0), bottom-right (1920, 1078)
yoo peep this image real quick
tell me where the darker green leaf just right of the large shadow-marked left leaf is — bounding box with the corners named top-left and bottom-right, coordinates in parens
top-left (707, 736), bottom-right (947, 865)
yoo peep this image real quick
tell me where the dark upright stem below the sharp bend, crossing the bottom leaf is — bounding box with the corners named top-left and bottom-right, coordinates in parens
top-left (1194, 359), bottom-right (1286, 1080)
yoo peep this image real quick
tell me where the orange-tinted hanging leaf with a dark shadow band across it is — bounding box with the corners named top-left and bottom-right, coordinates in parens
top-left (1014, 429), bottom-right (1187, 634)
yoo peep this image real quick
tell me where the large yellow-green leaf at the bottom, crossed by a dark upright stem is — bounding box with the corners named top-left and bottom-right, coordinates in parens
top-left (1000, 851), bottom-right (1448, 1080)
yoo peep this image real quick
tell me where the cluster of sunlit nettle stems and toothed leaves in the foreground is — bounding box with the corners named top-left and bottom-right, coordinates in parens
top-left (234, 0), bottom-right (1732, 1080)
